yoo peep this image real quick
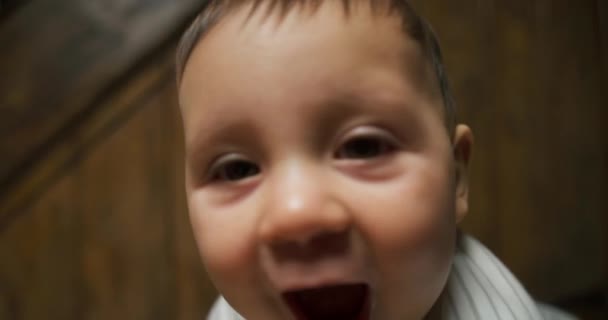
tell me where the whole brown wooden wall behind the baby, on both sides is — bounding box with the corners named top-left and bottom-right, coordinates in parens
top-left (0, 0), bottom-right (608, 320)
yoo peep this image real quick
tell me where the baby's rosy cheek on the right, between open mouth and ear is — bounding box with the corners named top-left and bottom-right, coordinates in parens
top-left (356, 175), bottom-right (455, 314)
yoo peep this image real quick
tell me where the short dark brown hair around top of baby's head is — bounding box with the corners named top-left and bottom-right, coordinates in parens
top-left (176, 0), bottom-right (456, 130)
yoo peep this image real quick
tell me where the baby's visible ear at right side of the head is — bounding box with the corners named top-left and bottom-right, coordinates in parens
top-left (452, 124), bottom-right (473, 223)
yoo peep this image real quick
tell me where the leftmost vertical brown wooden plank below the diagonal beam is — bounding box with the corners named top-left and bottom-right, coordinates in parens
top-left (0, 178), bottom-right (84, 320)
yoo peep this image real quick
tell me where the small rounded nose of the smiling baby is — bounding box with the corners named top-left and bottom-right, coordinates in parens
top-left (259, 162), bottom-right (352, 249)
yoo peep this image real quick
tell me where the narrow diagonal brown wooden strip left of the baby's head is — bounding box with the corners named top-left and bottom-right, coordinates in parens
top-left (0, 40), bottom-right (173, 231)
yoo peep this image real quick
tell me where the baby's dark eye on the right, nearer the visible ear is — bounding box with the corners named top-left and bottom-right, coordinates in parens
top-left (336, 136), bottom-right (395, 159)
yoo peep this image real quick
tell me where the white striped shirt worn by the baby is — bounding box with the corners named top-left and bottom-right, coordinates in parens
top-left (207, 234), bottom-right (576, 320)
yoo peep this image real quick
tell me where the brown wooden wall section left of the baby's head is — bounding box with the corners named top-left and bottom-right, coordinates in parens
top-left (0, 0), bottom-right (215, 320)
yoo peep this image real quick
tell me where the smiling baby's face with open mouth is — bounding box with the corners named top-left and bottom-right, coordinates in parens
top-left (179, 1), bottom-right (467, 320)
